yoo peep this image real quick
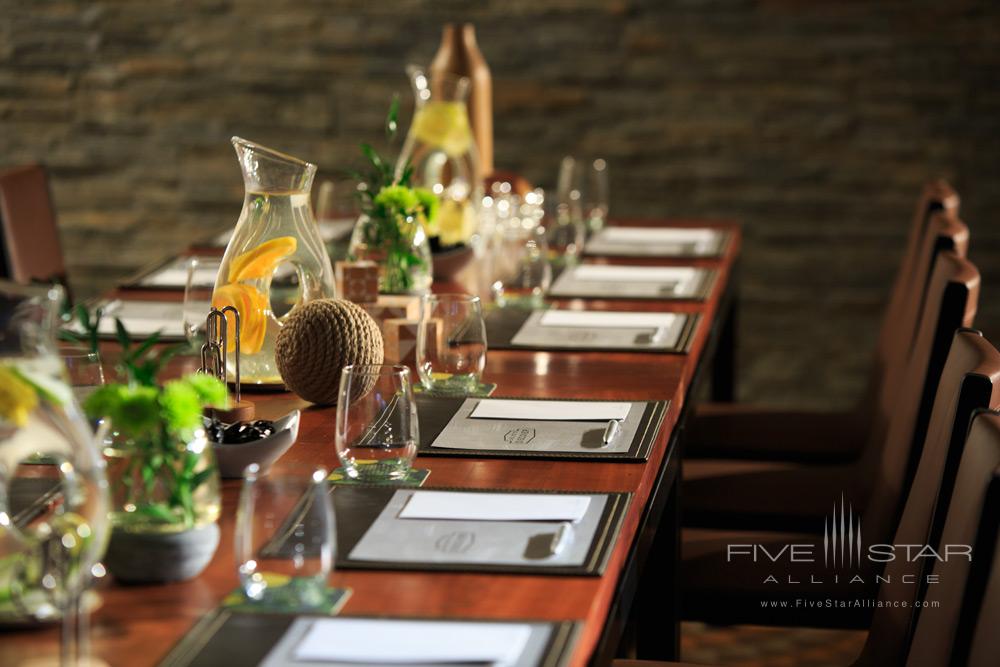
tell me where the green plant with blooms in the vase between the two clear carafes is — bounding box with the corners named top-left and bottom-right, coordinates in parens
top-left (351, 98), bottom-right (438, 293)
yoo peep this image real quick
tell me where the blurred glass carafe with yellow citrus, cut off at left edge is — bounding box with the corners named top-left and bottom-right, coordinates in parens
top-left (0, 282), bottom-right (110, 665)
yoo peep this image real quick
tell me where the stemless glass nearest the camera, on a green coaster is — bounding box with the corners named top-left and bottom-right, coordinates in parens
top-left (234, 463), bottom-right (336, 609)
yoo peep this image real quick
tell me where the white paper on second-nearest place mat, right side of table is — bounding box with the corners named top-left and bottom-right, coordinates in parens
top-left (399, 491), bottom-right (590, 521)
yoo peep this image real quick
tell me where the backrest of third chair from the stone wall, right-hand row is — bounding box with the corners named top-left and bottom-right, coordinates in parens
top-left (851, 250), bottom-right (979, 543)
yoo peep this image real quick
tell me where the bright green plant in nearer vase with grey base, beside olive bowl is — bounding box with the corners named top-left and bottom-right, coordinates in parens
top-left (81, 314), bottom-right (228, 528)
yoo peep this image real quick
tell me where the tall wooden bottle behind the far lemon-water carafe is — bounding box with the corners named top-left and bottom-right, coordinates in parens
top-left (429, 23), bottom-right (493, 178)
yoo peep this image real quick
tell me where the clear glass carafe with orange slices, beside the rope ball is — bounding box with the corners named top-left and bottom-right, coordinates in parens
top-left (213, 137), bottom-right (334, 387)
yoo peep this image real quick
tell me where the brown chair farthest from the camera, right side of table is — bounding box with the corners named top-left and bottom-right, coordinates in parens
top-left (685, 181), bottom-right (968, 462)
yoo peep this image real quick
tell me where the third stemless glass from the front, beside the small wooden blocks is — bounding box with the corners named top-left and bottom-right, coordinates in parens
top-left (417, 294), bottom-right (486, 395)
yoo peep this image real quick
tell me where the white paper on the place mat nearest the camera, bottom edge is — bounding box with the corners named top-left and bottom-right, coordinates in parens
top-left (295, 618), bottom-right (531, 665)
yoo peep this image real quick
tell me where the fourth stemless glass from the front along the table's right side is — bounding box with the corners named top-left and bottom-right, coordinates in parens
top-left (490, 227), bottom-right (552, 308)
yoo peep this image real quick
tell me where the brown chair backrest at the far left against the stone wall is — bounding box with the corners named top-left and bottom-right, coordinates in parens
top-left (0, 165), bottom-right (66, 283)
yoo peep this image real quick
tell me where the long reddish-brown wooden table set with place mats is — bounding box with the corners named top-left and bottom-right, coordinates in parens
top-left (0, 221), bottom-right (741, 667)
